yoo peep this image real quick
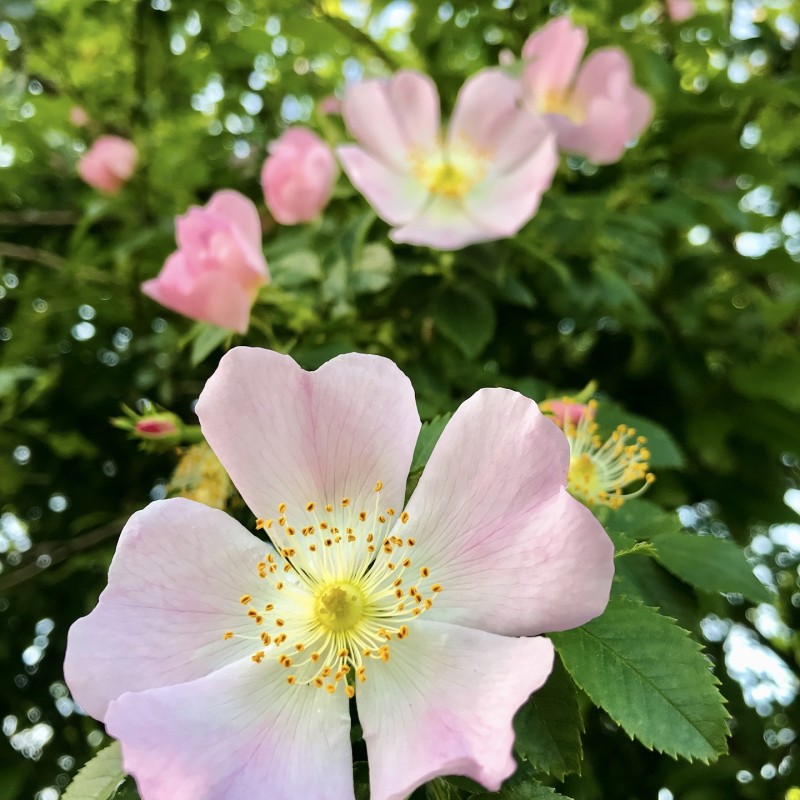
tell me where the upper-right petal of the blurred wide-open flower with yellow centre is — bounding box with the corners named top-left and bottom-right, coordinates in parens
top-left (447, 69), bottom-right (520, 155)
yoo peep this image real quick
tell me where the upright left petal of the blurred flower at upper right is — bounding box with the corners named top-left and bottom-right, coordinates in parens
top-left (522, 17), bottom-right (587, 95)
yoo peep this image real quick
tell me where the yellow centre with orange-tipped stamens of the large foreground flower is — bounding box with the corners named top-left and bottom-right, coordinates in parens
top-left (222, 481), bottom-right (442, 697)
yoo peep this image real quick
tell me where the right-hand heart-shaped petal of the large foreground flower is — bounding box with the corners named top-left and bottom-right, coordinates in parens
top-left (396, 389), bottom-right (614, 635)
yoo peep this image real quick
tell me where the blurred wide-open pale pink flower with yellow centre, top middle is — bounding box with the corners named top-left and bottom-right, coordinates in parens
top-left (337, 70), bottom-right (558, 250)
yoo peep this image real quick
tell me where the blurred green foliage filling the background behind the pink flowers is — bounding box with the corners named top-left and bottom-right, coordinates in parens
top-left (0, 0), bottom-right (800, 800)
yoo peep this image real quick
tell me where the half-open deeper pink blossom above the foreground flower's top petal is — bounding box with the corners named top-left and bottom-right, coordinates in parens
top-left (142, 189), bottom-right (269, 333)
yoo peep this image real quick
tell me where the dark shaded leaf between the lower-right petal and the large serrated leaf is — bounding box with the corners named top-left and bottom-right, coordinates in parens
top-left (514, 658), bottom-right (583, 780)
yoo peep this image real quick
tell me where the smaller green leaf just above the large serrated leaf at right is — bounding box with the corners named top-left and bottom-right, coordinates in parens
top-left (654, 533), bottom-right (770, 603)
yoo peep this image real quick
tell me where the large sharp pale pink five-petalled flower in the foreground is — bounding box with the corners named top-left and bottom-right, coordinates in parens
top-left (65, 347), bottom-right (614, 800)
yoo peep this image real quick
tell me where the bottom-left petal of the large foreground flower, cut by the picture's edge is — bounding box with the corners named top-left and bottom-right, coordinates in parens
top-left (106, 658), bottom-right (353, 800)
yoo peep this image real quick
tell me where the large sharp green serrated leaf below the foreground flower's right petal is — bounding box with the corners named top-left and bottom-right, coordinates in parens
top-left (550, 598), bottom-right (729, 762)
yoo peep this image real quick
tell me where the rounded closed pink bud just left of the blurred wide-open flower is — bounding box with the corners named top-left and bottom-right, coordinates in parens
top-left (261, 127), bottom-right (336, 225)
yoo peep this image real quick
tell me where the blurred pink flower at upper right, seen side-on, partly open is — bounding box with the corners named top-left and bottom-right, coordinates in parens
top-left (521, 17), bottom-right (653, 164)
